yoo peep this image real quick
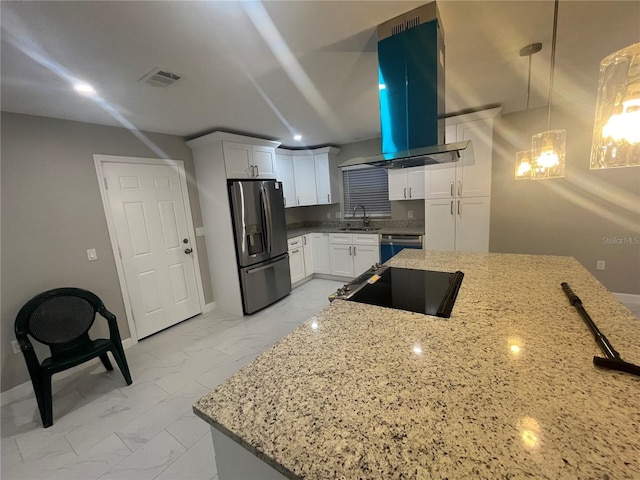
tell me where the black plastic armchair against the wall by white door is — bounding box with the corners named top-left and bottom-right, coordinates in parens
top-left (15, 288), bottom-right (133, 428)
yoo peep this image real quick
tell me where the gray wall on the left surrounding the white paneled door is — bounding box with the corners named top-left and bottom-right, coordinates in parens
top-left (0, 112), bottom-right (212, 391)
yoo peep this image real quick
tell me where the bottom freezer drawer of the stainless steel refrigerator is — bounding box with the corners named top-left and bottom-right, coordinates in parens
top-left (240, 254), bottom-right (291, 314)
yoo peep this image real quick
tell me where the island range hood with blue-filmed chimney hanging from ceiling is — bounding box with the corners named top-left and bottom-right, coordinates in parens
top-left (340, 2), bottom-right (469, 168)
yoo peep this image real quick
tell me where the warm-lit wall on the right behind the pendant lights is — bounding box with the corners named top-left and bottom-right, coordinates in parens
top-left (489, 106), bottom-right (640, 295)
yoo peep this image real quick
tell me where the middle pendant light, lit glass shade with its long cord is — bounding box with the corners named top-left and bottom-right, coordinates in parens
top-left (531, 0), bottom-right (567, 180)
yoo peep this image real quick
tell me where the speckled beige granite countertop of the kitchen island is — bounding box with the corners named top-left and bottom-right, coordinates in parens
top-left (194, 250), bottom-right (640, 480)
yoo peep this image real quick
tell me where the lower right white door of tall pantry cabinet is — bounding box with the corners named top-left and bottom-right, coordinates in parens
top-left (455, 197), bottom-right (491, 252)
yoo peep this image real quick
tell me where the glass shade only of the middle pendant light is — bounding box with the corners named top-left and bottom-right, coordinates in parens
top-left (531, 130), bottom-right (567, 180)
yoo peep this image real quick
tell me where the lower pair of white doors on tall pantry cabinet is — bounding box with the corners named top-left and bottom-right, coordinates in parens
top-left (425, 197), bottom-right (491, 252)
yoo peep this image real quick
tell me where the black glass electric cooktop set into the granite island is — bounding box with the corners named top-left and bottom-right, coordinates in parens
top-left (329, 265), bottom-right (464, 318)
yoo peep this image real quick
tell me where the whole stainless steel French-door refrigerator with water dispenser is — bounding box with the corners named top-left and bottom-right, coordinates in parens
top-left (228, 180), bottom-right (291, 313)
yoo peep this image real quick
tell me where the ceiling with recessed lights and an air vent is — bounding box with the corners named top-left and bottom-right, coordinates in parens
top-left (1, 0), bottom-right (640, 147)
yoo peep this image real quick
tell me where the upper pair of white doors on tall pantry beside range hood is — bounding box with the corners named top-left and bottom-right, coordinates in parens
top-left (425, 108), bottom-right (501, 199)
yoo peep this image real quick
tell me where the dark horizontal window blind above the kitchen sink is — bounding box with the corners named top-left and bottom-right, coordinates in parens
top-left (342, 167), bottom-right (391, 217)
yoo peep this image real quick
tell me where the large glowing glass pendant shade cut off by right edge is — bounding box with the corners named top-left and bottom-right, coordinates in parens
top-left (590, 43), bottom-right (640, 169)
